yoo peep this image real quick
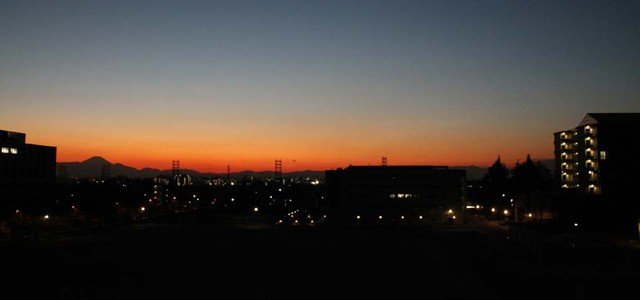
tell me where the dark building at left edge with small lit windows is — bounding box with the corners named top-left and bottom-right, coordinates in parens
top-left (0, 130), bottom-right (56, 184)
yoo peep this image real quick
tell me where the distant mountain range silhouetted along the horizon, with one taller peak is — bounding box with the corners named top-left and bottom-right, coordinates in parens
top-left (57, 156), bottom-right (554, 180)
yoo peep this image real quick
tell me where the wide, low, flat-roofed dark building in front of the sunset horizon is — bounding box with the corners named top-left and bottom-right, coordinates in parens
top-left (326, 166), bottom-right (466, 225)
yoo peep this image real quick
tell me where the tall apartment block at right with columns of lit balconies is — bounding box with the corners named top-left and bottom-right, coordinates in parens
top-left (554, 113), bottom-right (640, 194)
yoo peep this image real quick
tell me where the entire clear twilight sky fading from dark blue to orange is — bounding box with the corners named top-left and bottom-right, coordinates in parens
top-left (0, 0), bottom-right (640, 172)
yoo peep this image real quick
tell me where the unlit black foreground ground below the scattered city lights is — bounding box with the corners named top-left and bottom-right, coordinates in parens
top-left (0, 212), bottom-right (640, 299)
